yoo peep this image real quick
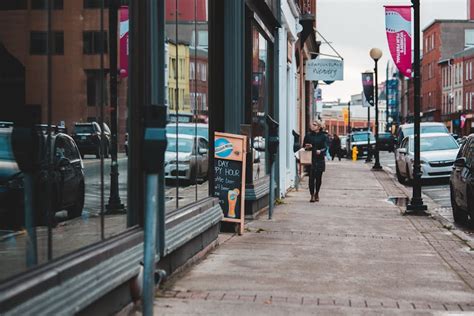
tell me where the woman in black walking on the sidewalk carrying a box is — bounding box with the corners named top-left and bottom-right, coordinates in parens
top-left (303, 121), bottom-right (327, 203)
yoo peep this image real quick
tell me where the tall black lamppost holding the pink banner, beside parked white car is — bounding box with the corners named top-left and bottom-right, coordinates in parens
top-left (406, 0), bottom-right (427, 214)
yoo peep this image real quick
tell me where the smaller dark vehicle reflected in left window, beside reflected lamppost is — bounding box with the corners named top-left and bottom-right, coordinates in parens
top-left (72, 122), bottom-right (111, 158)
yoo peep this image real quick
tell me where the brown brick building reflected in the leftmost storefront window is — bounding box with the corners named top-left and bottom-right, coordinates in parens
top-left (0, 0), bottom-right (128, 144)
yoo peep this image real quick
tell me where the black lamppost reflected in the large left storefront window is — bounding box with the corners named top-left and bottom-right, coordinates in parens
top-left (105, 0), bottom-right (125, 213)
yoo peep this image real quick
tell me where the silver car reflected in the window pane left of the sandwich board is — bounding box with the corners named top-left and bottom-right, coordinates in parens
top-left (165, 134), bottom-right (209, 182)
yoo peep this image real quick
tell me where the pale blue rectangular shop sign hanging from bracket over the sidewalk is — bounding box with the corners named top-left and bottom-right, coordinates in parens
top-left (306, 58), bottom-right (344, 82)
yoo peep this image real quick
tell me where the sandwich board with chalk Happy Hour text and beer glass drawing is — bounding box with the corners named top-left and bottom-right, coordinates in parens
top-left (214, 132), bottom-right (247, 234)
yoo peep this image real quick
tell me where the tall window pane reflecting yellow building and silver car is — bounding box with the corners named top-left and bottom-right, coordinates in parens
top-left (165, 0), bottom-right (211, 212)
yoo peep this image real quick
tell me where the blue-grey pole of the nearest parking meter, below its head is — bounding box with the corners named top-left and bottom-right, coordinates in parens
top-left (143, 174), bottom-right (158, 316)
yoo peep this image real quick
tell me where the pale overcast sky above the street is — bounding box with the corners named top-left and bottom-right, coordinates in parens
top-left (316, 0), bottom-right (467, 101)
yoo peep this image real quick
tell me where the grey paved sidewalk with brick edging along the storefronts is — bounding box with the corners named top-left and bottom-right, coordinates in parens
top-left (155, 161), bottom-right (474, 315)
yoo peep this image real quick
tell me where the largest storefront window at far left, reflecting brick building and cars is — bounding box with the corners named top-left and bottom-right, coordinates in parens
top-left (0, 0), bottom-right (132, 282)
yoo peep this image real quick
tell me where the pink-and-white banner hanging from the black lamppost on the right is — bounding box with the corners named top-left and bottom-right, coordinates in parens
top-left (385, 6), bottom-right (412, 78)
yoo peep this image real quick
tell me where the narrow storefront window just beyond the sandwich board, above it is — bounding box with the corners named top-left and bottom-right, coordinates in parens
top-left (252, 25), bottom-right (270, 180)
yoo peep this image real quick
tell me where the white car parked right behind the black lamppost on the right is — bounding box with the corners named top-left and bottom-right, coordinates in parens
top-left (395, 133), bottom-right (459, 183)
